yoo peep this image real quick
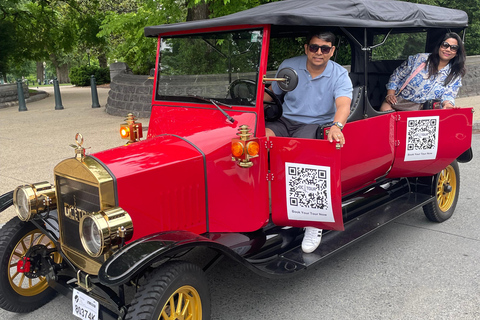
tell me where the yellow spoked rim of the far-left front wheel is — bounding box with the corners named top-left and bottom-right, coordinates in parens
top-left (8, 229), bottom-right (61, 296)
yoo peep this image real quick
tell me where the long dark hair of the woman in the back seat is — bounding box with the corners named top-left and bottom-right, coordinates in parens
top-left (425, 32), bottom-right (467, 86)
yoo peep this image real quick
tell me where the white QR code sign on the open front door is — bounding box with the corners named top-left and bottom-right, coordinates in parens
top-left (285, 162), bottom-right (335, 222)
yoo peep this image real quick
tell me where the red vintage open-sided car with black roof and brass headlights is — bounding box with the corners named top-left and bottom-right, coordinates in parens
top-left (0, 0), bottom-right (473, 319)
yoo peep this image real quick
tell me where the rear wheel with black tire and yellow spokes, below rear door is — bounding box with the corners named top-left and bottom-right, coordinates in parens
top-left (423, 160), bottom-right (460, 222)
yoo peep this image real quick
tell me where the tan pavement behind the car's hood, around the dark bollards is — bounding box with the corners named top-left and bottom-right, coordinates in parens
top-left (0, 86), bottom-right (129, 223)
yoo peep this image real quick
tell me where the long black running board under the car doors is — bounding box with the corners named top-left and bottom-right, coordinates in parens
top-left (249, 193), bottom-right (435, 278)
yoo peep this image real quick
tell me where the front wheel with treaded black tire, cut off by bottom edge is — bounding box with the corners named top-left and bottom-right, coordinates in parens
top-left (126, 261), bottom-right (210, 320)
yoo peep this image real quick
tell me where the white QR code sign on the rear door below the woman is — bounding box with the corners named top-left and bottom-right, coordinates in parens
top-left (404, 116), bottom-right (439, 161)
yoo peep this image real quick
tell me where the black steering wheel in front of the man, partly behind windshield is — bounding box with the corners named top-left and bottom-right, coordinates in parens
top-left (228, 79), bottom-right (283, 122)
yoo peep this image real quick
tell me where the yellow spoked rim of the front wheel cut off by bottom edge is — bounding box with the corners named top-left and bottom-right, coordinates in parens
top-left (158, 286), bottom-right (202, 320)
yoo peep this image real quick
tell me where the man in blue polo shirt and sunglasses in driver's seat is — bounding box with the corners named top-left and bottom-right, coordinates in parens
top-left (264, 32), bottom-right (353, 253)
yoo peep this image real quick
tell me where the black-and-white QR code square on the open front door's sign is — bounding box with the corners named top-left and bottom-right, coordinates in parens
top-left (287, 166), bottom-right (329, 210)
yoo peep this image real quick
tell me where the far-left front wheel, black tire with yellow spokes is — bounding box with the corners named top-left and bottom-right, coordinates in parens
top-left (0, 217), bottom-right (61, 313)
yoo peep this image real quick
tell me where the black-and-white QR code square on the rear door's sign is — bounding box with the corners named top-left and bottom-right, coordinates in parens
top-left (407, 118), bottom-right (438, 151)
